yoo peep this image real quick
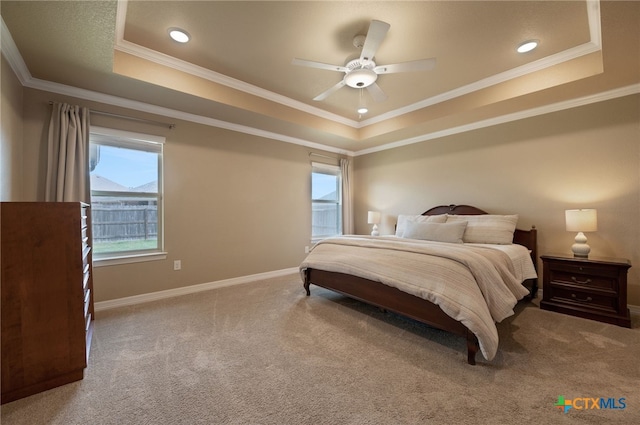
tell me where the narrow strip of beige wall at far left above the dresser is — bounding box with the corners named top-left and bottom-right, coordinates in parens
top-left (0, 56), bottom-right (22, 201)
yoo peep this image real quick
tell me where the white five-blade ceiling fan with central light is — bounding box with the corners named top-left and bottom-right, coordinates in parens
top-left (291, 19), bottom-right (436, 102)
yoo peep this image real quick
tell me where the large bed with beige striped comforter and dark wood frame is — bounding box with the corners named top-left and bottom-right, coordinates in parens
top-left (300, 205), bottom-right (538, 365)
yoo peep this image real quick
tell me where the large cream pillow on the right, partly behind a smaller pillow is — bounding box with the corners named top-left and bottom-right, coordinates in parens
top-left (447, 214), bottom-right (518, 245)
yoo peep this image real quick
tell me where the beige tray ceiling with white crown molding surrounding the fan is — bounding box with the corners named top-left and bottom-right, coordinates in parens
top-left (0, 0), bottom-right (640, 152)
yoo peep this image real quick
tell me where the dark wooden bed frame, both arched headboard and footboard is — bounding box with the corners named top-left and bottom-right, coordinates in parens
top-left (304, 205), bottom-right (538, 365)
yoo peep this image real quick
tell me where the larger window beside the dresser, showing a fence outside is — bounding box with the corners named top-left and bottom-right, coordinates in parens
top-left (89, 127), bottom-right (164, 261)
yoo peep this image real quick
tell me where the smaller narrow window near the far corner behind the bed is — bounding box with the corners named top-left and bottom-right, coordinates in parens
top-left (311, 162), bottom-right (342, 240)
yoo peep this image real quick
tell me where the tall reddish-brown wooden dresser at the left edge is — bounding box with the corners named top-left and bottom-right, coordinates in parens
top-left (0, 202), bottom-right (93, 403)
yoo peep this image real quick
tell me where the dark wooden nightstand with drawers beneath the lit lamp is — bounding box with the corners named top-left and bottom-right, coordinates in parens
top-left (540, 254), bottom-right (631, 328)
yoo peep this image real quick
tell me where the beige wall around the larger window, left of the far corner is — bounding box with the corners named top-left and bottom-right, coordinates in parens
top-left (18, 89), bottom-right (340, 301)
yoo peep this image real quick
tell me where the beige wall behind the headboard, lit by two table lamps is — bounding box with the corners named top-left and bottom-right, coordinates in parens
top-left (354, 95), bottom-right (640, 305)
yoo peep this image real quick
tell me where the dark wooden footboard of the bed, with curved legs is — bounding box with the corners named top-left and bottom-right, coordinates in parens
top-left (304, 269), bottom-right (479, 365)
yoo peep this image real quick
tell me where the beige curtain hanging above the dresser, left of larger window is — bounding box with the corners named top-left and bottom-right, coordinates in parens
top-left (45, 103), bottom-right (91, 203)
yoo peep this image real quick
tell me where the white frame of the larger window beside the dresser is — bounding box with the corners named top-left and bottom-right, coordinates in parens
top-left (89, 126), bottom-right (167, 267)
